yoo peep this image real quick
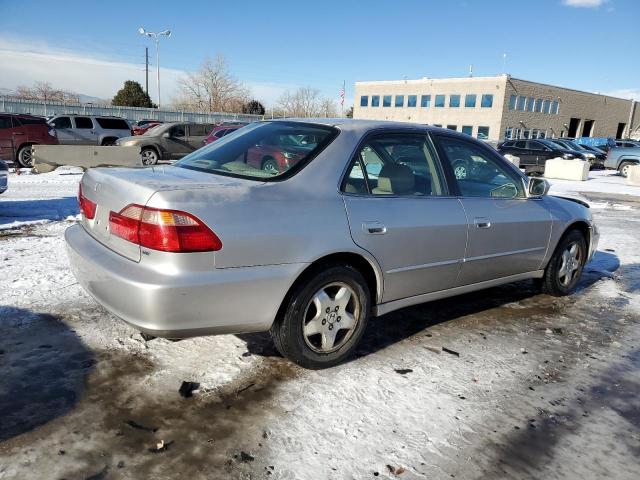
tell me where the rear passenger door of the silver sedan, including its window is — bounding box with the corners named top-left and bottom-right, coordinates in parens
top-left (342, 132), bottom-right (467, 302)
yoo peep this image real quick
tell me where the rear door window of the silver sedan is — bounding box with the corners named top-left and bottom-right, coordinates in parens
top-left (342, 134), bottom-right (444, 197)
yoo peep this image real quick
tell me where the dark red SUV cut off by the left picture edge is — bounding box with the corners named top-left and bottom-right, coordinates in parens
top-left (0, 113), bottom-right (58, 167)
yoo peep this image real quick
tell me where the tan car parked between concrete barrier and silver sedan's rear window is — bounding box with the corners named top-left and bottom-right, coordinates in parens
top-left (116, 122), bottom-right (215, 165)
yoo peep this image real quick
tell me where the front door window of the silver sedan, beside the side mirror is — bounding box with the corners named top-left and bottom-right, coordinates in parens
top-left (437, 136), bottom-right (525, 198)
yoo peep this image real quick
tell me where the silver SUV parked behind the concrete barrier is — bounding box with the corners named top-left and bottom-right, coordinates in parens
top-left (49, 115), bottom-right (131, 146)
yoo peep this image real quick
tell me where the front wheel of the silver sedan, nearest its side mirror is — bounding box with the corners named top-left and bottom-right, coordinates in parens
top-left (542, 230), bottom-right (588, 297)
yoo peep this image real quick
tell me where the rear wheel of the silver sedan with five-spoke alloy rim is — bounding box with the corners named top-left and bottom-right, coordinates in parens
top-left (270, 265), bottom-right (371, 370)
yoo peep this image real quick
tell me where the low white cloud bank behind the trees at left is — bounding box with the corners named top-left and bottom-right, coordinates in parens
top-left (0, 37), bottom-right (297, 105)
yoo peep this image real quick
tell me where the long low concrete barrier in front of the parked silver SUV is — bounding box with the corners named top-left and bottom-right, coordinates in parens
top-left (32, 145), bottom-right (142, 173)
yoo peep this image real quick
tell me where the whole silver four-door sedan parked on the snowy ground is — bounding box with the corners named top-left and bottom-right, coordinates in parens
top-left (65, 119), bottom-right (598, 368)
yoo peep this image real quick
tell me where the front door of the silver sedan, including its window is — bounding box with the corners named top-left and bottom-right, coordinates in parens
top-left (435, 134), bottom-right (552, 286)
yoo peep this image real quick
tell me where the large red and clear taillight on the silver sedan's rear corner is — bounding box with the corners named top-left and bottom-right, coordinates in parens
top-left (109, 205), bottom-right (222, 253)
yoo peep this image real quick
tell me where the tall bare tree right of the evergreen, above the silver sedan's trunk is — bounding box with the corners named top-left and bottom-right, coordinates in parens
top-left (172, 54), bottom-right (250, 112)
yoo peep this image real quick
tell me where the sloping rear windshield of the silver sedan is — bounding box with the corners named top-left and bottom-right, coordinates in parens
top-left (175, 121), bottom-right (338, 180)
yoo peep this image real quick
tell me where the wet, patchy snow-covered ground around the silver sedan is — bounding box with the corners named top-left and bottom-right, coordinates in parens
top-left (0, 193), bottom-right (640, 479)
